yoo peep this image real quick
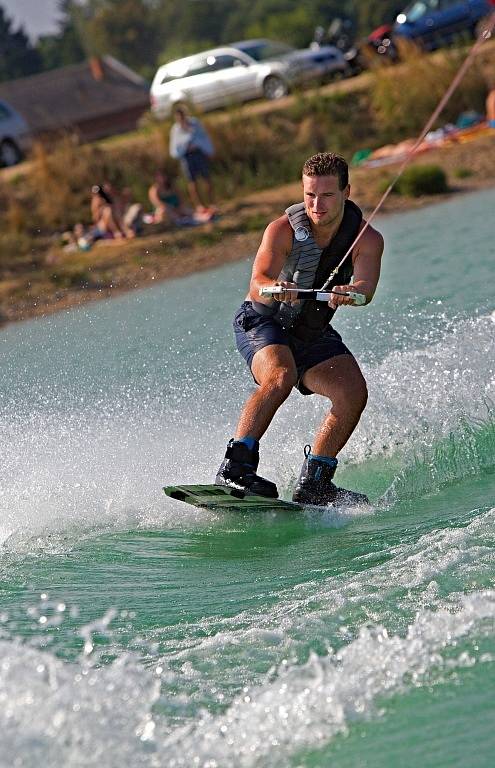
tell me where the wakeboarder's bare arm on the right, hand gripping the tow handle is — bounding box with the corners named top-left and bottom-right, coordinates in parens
top-left (329, 220), bottom-right (383, 308)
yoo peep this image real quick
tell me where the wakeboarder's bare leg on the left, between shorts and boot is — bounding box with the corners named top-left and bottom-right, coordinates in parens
top-left (235, 344), bottom-right (297, 440)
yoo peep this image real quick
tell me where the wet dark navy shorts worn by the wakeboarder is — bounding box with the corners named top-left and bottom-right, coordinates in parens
top-left (233, 301), bottom-right (352, 395)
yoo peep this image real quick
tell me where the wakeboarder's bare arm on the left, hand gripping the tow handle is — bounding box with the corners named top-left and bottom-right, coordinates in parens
top-left (249, 215), bottom-right (295, 306)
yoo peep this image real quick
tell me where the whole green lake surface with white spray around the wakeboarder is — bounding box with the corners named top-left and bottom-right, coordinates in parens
top-left (0, 191), bottom-right (495, 768)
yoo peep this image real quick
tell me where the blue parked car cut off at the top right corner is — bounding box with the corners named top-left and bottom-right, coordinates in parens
top-left (393, 0), bottom-right (495, 51)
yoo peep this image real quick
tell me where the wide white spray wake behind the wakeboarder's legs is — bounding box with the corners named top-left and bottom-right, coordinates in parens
top-left (0, 308), bottom-right (495, 548)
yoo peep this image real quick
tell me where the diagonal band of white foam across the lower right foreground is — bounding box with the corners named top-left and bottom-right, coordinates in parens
top-left (165, 590), bottom-right (495, 768)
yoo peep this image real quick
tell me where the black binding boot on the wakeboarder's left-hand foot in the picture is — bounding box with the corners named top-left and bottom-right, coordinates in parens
top-left (215, 438), bottom-right (278, 499)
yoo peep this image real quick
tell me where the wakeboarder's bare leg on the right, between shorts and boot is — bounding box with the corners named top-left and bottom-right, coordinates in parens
top-left (302, 355), bottom-right (368, 458)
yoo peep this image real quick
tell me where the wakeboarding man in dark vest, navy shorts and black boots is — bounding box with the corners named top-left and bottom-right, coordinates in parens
top-left (215, 152), bottom-right (383, 505)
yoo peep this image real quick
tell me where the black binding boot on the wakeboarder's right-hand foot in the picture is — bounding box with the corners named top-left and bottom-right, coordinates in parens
top-left (292, 445), bottom-right (369, 506)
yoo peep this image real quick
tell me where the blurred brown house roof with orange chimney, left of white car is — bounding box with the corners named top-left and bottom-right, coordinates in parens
top-left (0, 56), bottom-right (149, 133)
